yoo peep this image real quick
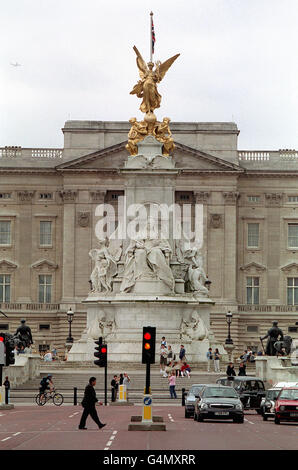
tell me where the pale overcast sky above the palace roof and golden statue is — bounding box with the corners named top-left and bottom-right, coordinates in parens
top-left (0, 0), bottom-right (298, 150)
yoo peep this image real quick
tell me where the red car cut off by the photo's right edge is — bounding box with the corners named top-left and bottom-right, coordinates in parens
top-left (274, 387), bottom-right (298, 424)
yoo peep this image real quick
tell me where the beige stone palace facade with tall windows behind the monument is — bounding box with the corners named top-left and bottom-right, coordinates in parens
top-left (0, 121), bottom-right (298, 353)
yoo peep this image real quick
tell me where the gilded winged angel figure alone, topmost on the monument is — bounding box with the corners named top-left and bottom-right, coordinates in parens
top-left (130, 46), bottom-right (180, 113)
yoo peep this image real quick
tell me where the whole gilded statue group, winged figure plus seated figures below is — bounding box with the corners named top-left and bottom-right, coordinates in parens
top-left (126, 46), bottom-right (180, 156)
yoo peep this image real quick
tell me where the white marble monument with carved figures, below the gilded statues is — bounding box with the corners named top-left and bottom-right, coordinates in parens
top-left (68, 136), bottom-right (214, 364)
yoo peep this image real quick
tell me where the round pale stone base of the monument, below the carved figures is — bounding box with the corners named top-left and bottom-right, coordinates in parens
top-left (68, 294), bottom-right (213, 364)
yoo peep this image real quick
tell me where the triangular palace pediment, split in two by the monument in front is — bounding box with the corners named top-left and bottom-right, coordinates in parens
top-left (56, 141), bottom-right (243, 172)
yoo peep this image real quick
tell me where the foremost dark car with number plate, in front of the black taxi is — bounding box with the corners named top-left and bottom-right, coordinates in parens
top-left (194, 384), bottom-right (244, 423)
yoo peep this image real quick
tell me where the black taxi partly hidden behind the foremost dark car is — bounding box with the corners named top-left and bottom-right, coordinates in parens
top-left (216, 376), bottom-right (266, 414)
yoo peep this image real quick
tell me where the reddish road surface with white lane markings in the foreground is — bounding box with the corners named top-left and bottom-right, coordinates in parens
top-left (0, 403), bottom-right (298, 452)
